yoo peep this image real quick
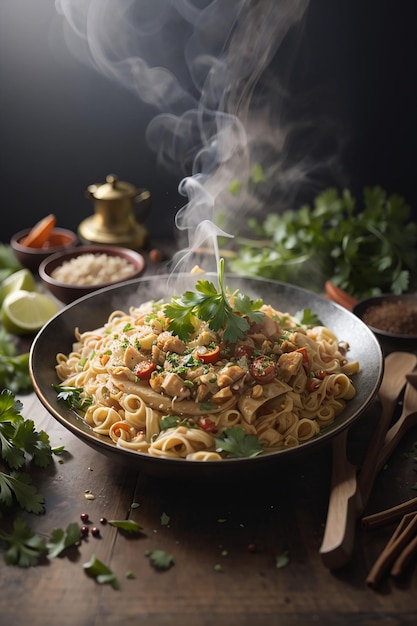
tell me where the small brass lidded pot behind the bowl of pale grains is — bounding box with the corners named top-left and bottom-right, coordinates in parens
top-left (78, 174), bottom-right (151, 250)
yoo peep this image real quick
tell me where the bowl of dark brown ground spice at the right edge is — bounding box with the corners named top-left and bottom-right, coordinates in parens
top-left (353, 293), bottom-right (417, 355)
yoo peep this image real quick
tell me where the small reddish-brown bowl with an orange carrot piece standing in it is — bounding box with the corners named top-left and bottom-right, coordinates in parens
top-left (10, 227), bottom-right (78, 272)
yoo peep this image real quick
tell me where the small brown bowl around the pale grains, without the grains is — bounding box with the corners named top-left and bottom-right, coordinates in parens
top-left (39, 245), bottom-right (145, 304)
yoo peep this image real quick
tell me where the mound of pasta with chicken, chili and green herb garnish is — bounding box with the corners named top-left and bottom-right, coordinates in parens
top-left (54, 263), bottom-right (359, 461)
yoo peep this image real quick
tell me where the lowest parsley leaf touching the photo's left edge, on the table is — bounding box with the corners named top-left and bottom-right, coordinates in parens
top-left (0, 517), bottom-right (47, 567)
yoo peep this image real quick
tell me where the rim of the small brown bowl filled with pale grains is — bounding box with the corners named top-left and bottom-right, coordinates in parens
top-left (38, 244), bottom-right (146, 292)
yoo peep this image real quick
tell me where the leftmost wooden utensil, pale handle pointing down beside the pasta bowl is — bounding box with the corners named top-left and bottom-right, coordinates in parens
top-left (320, 429), bottom-right (358, 569)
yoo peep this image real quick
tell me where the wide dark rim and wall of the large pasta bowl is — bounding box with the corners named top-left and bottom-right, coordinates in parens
top-left (29, 274), bottom-right (384, 480)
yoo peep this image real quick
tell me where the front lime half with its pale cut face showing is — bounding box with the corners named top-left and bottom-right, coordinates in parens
top-left (1, 289), bottom-right (58, 335)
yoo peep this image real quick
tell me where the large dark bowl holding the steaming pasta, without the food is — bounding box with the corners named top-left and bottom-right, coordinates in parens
top-left (30, 274), bottom-right (383, 482)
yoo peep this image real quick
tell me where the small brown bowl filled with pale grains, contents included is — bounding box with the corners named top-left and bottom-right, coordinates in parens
top-left (39, 244), bottom-right (145, 304)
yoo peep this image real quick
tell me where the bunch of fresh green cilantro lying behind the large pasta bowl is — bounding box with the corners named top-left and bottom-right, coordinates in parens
top-left (229, 187), bottom-right (417, 299)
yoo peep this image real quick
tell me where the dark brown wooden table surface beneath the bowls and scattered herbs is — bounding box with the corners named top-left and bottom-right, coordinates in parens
top-left (0, 244), bottom-right (417, 626)
